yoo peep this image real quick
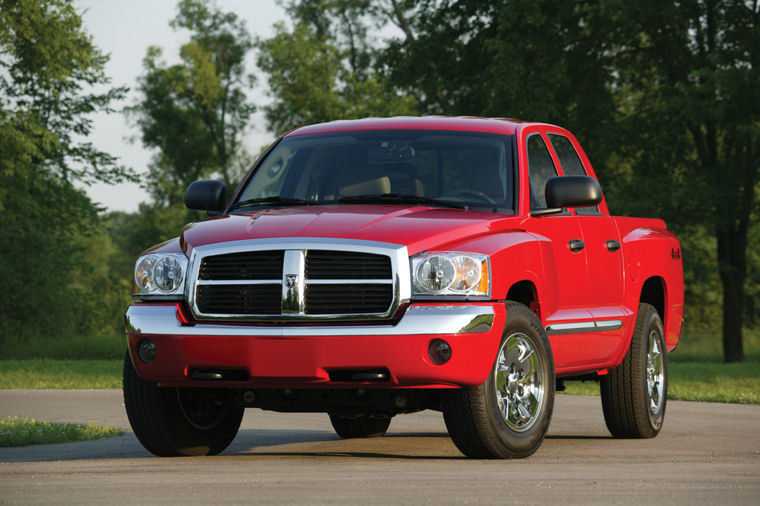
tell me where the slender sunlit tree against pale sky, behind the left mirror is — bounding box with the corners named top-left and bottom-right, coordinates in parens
top-left (128, 0), bottom-right (255, 205)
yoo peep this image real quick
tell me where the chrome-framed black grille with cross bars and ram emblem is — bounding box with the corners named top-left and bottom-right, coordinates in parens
top-left (188, 239), bottom-right (409, 320)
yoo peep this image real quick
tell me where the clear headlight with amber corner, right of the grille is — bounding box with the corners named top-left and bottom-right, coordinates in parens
top-left (411, 252), bottom-right (491, 296)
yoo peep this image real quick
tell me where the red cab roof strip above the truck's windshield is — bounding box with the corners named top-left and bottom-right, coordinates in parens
top-left (285, 116), bottom-right (526, 137)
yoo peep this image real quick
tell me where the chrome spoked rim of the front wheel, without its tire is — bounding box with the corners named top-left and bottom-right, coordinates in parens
top-left (494, 332), bottom-right (545, 432)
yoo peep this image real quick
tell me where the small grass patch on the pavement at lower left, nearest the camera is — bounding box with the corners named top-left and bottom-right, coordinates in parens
top-left (0, 417), bottom-right (124, 447)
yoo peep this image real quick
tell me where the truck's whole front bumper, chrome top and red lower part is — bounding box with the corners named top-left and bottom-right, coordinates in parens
top-left (126, 302), bottom-right (506, 388)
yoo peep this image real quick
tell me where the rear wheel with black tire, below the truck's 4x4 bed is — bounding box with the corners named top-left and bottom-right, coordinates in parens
top-left (600, 304), bottom-right (668, 438)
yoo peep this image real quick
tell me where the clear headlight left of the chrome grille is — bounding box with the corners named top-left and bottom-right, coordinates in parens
top-left (135, 253), bottom-right (187, 296)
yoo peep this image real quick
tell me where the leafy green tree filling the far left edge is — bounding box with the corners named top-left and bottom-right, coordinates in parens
top-left (0, 0), bottom-right (130, 341)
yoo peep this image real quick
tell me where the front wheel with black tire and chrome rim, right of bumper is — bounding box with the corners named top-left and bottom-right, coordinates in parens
top-left (443, 302), bottom-right (555, 459)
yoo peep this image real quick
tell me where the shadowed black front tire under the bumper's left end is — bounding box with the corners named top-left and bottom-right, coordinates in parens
top-left (123, 353), bottom-right (245, 457)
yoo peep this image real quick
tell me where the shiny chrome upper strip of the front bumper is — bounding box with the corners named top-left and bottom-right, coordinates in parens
top-left (125, 304), bottom-right (494, 337)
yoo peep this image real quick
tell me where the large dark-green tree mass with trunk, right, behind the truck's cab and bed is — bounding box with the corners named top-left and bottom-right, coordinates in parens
top-left (381, 0), bottom-right (760, 362)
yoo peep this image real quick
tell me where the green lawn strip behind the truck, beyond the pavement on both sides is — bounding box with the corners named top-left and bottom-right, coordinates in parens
top-left (0, 329), bottom-right (760, 404)
